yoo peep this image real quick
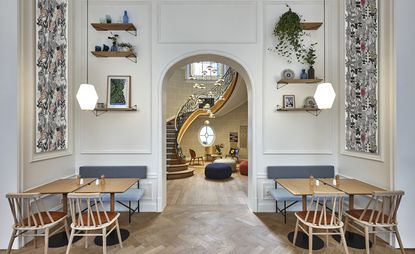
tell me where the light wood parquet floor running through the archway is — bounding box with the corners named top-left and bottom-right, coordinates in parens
top-left (2, 164), bottom-right (415, 254)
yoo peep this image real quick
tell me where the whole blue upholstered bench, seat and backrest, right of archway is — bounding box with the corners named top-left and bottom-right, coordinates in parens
top-left (267, 165), bottom-right (334, 223)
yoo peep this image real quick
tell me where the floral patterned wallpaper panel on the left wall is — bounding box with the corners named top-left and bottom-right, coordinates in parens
top-left (35, 0), bottom-right (68, 153)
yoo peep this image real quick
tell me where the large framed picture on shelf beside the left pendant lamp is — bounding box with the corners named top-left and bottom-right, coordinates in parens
top-left (107, 76), bottom-right (131, 108)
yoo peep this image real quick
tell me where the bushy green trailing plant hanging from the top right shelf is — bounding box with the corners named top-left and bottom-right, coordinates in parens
top-left (273, 5), bottom-right (305, 63)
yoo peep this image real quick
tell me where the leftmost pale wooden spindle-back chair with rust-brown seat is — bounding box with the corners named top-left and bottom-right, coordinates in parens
top-left (6, 193), bottom-right (69, 254)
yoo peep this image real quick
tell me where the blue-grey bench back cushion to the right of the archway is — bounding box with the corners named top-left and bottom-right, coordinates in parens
top-left (267, 165), bottom-right (334, 179)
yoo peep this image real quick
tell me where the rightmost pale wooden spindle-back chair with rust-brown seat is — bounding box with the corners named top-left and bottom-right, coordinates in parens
top-left (345, 191), bottom-right (405, 254)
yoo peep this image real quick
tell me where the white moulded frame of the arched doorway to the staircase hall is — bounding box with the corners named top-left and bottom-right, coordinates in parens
top-left (158, 52), bottom-right (257, 211)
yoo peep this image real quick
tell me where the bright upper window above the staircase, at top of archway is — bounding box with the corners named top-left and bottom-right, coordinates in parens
top-left (185, 62), bottom-right (227, 81)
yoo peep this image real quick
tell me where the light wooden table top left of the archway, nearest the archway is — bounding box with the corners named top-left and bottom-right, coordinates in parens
top-left (75, 178), bottom-right (140, 193)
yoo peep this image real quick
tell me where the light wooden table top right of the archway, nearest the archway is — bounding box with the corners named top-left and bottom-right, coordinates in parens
top-left (276, 178), bottom-right (340, 196)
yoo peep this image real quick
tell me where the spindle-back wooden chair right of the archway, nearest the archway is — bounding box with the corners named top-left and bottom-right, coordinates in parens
top-left (293, 192), bottom-right (349, 253)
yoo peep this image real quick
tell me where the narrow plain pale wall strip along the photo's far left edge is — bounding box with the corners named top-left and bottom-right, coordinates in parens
top-left (0, 1), bottom-right (20, 249)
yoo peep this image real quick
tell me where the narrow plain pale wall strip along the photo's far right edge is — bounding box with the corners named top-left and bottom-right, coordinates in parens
top-left (394, 0), bottom-right (415, 248)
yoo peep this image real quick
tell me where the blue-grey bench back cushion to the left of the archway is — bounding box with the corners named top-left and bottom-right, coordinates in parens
top-left (79, 166), bottom-right (147, 179)
